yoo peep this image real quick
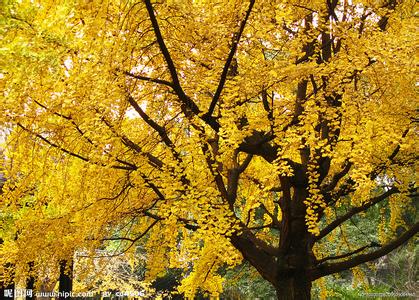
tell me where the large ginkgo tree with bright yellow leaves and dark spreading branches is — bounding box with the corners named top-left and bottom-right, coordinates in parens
top-left (0, 0), bottom-right (419, 299)
